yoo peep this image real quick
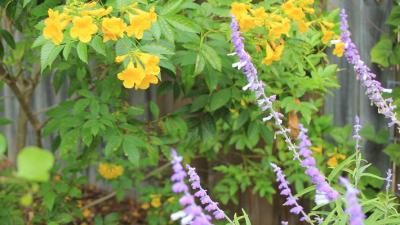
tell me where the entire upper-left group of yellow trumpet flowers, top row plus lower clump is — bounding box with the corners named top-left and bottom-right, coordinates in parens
top-left (43, 1), bottom-right (160, 89)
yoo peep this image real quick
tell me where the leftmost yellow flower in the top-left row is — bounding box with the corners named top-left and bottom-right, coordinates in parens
top-left (43, 9), bottom-right (68, 45)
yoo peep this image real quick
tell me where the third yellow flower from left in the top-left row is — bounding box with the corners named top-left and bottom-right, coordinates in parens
top-left (101, 17), bottom-right (126, 42)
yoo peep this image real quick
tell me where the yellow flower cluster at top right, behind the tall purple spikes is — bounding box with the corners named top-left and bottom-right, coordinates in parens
top-left (231, 0), bottom-right (344, 65)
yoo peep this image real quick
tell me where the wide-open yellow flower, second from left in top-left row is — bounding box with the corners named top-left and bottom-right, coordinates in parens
top-left (70, 16), bottom-right (97, 43)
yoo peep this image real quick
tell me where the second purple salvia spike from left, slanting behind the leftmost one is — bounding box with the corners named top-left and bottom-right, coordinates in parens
top-left (186, 165), bottom-right (226, 220)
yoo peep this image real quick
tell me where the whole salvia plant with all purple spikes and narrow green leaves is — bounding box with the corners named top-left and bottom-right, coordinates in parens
top-left (166, 11), bottom-right (400, 225)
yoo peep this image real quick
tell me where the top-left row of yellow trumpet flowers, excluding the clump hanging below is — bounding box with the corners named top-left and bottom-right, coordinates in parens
top-left (43, 1), bottom-right (157, 45)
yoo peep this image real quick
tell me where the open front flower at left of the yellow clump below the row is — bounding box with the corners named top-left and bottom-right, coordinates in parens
top-left (117, 62), bottom-right (146, 88)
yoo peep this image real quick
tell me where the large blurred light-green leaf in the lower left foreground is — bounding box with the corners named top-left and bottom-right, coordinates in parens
top-left (17, 147), bottom-right (54, 181)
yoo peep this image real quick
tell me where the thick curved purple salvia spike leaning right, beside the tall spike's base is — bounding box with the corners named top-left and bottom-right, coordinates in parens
top-left (297, 124), bottom-right (339, 203)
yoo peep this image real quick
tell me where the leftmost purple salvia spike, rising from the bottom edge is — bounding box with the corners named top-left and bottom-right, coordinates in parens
top-left (171, 150), bottom-right (212, 225)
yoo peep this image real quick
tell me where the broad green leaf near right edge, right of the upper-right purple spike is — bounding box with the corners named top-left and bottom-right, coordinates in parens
top-left (371, 36), bottom-right (393, 67)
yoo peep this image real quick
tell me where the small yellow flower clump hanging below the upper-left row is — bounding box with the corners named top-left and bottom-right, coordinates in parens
top-left (115, 50), bottom-right (160, 90)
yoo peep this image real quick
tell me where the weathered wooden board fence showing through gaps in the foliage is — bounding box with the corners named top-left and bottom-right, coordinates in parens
top-left (0, 0), bottom-right (395, 225)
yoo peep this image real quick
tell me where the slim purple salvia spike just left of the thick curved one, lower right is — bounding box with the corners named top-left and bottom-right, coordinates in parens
top-left (271, 163), bottom-right (312, 223)
